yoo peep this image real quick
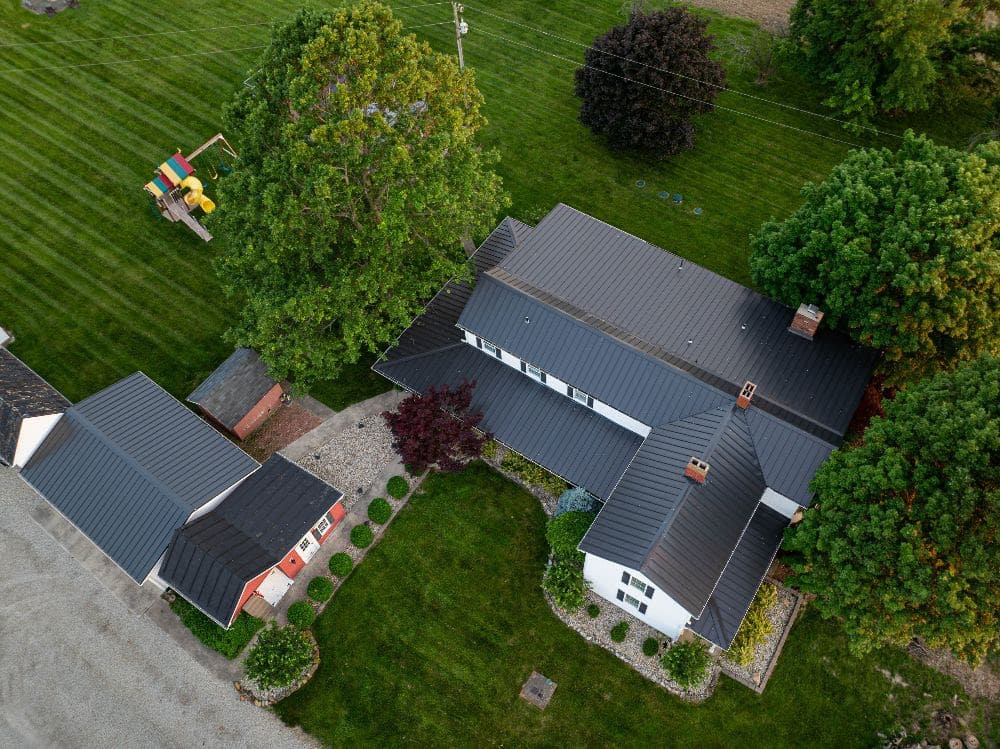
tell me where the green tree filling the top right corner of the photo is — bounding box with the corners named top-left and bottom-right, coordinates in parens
top-left (789, 0), bottom-right (1000, 124)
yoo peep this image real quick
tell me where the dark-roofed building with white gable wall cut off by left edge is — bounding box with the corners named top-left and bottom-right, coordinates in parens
top-left (0, 346), bottom-right (70, 467)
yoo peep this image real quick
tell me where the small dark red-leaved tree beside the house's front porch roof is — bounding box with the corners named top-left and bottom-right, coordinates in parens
top-left (382, 381), bottom-right (490, 473)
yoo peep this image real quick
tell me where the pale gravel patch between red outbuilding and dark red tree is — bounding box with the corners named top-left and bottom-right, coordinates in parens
top-left (299, 414), bottom-right (396, 509)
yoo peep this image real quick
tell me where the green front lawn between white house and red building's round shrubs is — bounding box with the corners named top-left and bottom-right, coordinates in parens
top-left (276, 463), bottom-right (992, 749)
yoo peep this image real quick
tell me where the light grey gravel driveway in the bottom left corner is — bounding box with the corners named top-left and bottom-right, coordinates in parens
top-left (0, 467), bottom-right (311, 749)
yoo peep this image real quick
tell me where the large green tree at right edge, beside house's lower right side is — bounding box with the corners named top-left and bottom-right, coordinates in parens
top-left (785, 356), bottom-right (1000, 663)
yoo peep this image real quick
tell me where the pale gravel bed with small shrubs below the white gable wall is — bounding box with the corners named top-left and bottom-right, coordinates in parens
top-left (545, 591), bottom-right (720, 702)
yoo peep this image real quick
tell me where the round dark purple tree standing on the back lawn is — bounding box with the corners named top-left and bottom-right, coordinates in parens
top-left (576, 8), bottom-right (726, 156)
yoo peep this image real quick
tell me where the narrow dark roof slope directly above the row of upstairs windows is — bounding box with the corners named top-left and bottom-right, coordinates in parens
top-left (459, 275), bottom-right (728, 426)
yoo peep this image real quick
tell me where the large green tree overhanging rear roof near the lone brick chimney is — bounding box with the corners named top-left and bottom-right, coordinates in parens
top-left (750, 133), bottom-right (1000, 383)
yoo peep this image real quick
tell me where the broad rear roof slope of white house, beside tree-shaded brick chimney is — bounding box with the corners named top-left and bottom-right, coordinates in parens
top-left (497, 205), bottom-right (876, 435)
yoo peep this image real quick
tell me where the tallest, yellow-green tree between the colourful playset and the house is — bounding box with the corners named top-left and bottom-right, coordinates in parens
top-left (213, 2), bottom-right (505, 390)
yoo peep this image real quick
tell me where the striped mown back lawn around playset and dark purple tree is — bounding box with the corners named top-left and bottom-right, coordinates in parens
top-left (0, 0), bottom-right (979, 407)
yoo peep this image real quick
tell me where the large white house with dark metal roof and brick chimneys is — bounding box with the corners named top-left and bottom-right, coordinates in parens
top-left (375, 205), bottom-right (876, 649)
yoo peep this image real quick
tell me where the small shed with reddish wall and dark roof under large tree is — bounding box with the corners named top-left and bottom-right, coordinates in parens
top-left (187, 348), bottom-right (284, 439)
